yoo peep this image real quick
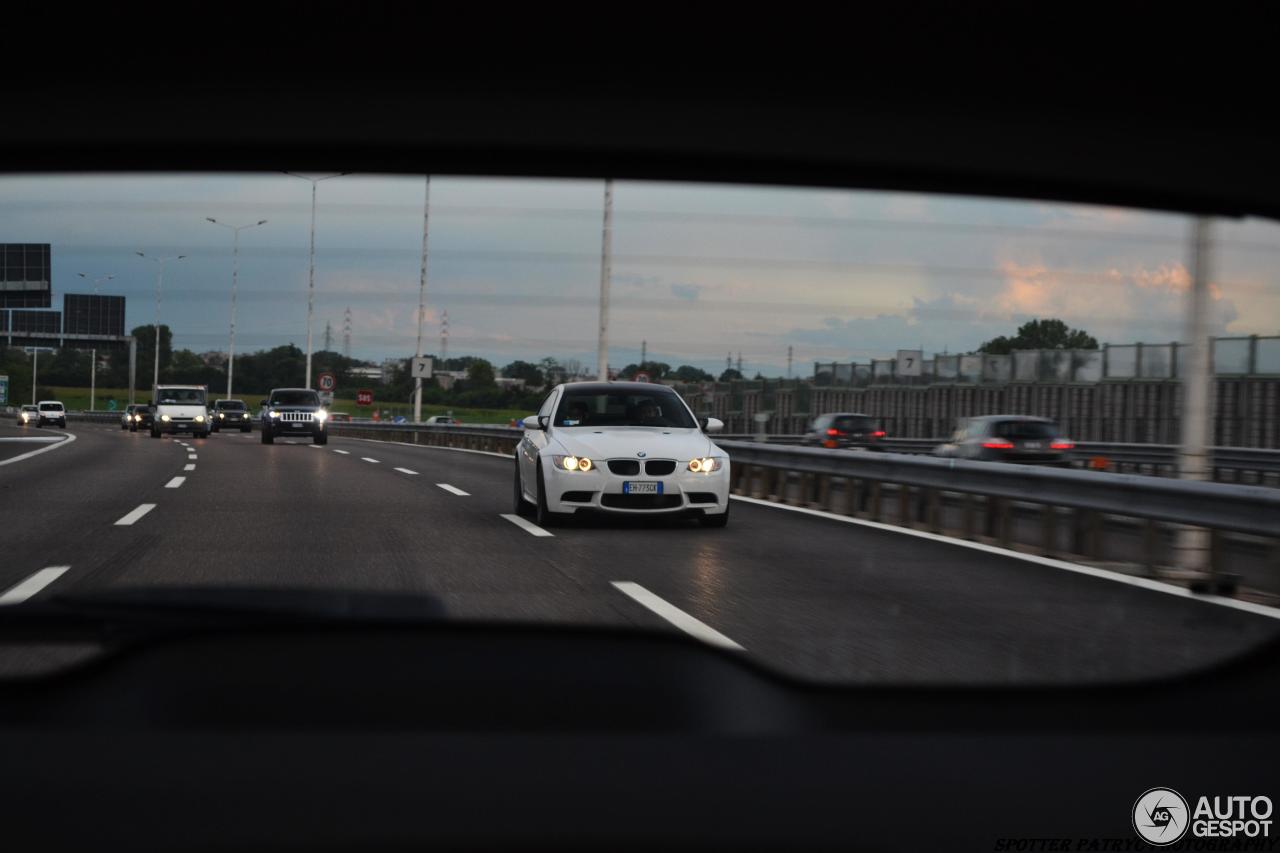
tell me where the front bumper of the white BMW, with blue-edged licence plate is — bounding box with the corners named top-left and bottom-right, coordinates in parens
top-left (540, 460), bottom-right (730, 515)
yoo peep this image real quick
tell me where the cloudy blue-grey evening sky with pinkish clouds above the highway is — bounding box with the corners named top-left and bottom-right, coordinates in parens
top-left (0, 174), bottom-right (1280, 375)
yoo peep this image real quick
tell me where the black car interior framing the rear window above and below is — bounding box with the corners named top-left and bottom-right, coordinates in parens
top-left (0, 4), bottom-right (1280, 852)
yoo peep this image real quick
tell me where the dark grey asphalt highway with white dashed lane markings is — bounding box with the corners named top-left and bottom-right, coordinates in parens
top-left (0, 423), bottom-right (1280, 683)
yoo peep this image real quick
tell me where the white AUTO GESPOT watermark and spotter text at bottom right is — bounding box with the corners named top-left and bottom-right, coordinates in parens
top-left (993, 788), bottom-right (1280, 853)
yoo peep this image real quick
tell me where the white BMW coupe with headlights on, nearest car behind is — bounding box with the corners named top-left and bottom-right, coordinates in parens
top-left (515, 382), bottom-right (730, 528)
